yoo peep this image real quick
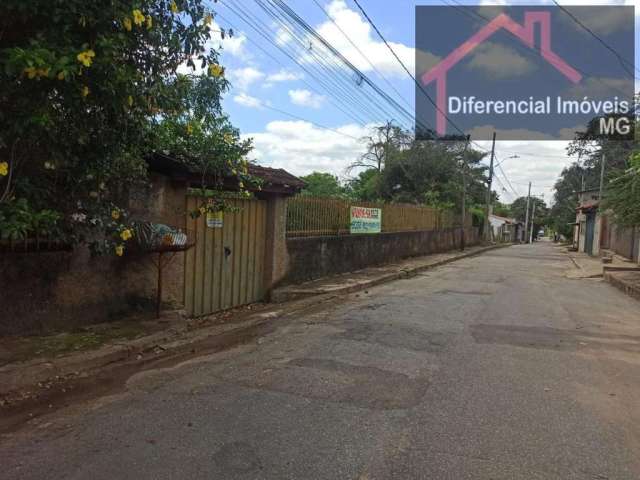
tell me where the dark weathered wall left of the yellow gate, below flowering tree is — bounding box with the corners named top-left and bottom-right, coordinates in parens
top-left (0, 175), bottom-right (186, 335)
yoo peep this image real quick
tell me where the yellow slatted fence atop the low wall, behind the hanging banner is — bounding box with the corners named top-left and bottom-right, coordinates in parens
top-left (287, 196), bottom-right (462, 237)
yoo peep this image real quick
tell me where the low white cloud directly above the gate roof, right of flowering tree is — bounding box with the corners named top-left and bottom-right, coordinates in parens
top-left (243, 121), bottom-right (373, 176)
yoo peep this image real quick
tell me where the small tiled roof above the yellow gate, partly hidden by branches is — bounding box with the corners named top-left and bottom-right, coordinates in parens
top-left (147, 152), bottom-right (306, 195)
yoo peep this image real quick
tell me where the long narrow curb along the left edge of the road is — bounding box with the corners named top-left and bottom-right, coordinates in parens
top-left (0, 244), bottom-right (511, 398)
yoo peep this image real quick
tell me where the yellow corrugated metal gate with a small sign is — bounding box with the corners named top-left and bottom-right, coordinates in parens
top-left (184, 197), bottom-right (267, 316)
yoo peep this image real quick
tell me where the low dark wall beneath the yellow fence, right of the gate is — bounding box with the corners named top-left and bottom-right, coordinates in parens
top-left (280, 227), bottom-right (480, 285)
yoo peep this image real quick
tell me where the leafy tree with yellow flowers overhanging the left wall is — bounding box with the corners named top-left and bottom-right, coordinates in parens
top-left (0, 0), bottom-right (249, 254)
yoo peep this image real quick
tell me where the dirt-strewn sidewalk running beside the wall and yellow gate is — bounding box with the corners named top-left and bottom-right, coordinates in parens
top-left (0, 245), bottom-right (506, 411)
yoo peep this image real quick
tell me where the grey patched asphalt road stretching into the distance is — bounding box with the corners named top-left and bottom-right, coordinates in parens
top-left (0, 243), bottom-right (640, 480)
